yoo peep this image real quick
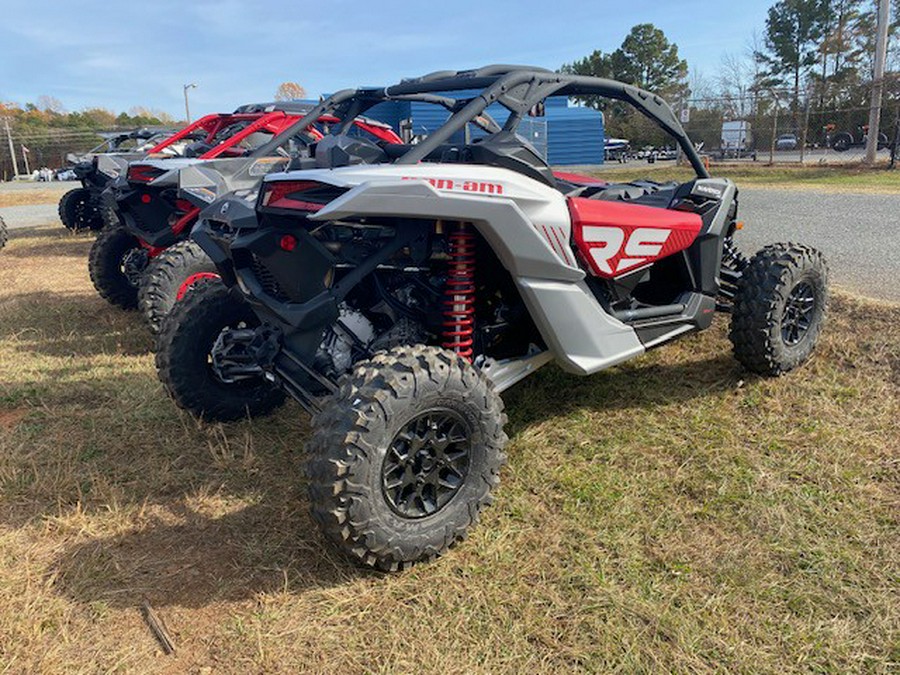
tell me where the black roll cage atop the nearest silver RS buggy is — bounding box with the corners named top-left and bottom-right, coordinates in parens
top-left (251, 65), bottom-right (709, 178)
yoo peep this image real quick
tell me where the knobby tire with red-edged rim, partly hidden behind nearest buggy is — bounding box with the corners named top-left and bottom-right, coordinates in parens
top-left (138, 241), bottom-right (216, 335)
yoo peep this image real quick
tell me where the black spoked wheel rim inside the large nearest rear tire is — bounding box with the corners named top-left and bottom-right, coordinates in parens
top-left (381, 409), bottom-right (471, 518)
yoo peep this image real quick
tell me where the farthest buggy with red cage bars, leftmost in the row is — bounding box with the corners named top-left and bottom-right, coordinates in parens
top-left (59, 103), bottom-right (311, 230)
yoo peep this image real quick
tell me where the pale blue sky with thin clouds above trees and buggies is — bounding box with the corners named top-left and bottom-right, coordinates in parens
top-left (0, 0), bottom-right (774, 116)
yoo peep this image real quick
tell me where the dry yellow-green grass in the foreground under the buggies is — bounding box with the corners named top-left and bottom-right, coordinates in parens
top-left (0, 228), bottom-right (900, 673)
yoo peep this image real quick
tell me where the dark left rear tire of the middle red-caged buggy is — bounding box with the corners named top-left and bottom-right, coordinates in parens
top-left (88, 227), bottom-right (142, 309)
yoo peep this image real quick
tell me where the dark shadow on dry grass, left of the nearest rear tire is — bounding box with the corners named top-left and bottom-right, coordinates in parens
top-left (53, 492), bottom-right (378, 608)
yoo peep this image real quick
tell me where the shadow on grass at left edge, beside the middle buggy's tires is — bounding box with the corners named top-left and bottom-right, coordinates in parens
top-left (0, 291), bottom-right (153, 357)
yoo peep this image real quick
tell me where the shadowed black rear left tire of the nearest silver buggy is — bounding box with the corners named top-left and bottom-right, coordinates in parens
top-left (156, 279), bottom-right (284, 422)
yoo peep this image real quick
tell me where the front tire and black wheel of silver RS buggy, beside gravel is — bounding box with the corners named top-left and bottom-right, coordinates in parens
top-left (729, 244), bottom-right (828, 375)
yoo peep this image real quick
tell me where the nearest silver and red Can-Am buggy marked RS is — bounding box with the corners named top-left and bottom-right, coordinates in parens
top-left (157, 66), bottom-right (827, 570)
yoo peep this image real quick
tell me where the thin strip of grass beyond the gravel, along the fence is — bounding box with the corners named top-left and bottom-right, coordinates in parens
top-left (592, 161), bottom-right (900, 194)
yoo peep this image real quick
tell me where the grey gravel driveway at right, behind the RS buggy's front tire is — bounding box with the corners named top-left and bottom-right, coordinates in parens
top-left (736, 188), bottom-right (900, 301)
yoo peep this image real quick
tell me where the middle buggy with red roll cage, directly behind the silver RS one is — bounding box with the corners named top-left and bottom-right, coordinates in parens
top-left (88, 103), bottom-right (400, 316)
